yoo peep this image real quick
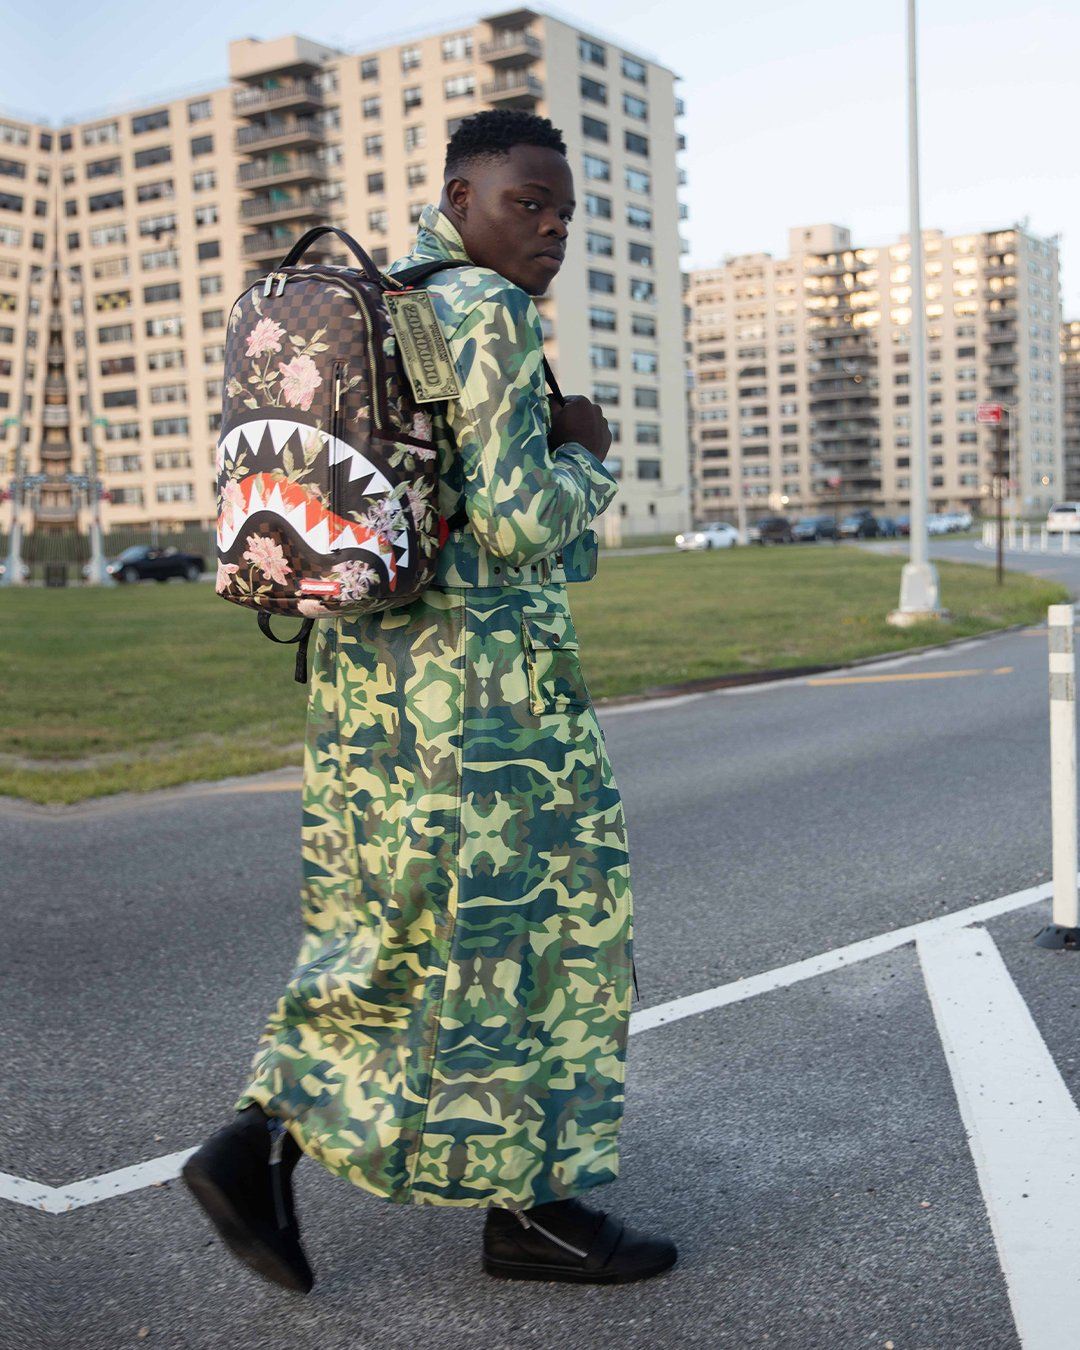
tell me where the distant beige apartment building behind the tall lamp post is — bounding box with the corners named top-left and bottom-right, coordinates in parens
top-left (687, 224), bottom-right (1064, 522)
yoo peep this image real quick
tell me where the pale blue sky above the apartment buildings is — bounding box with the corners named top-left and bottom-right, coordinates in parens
top-left (8, 0), bottom-right (1080, 309)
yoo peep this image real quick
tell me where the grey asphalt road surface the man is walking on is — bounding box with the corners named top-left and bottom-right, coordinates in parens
top-left (0, 541), bottom-right (1080, 1350)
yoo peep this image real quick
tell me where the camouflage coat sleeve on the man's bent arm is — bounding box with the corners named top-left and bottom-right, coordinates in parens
top-left (446, 282), bottom-right (618, 567)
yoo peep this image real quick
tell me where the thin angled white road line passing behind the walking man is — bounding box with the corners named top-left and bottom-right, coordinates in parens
top-left (0, 882), bottom-right (1053, 1214)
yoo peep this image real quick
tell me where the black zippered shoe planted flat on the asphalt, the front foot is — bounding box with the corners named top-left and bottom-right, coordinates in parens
top-left (483, 1199), bottom-right (679, 1284)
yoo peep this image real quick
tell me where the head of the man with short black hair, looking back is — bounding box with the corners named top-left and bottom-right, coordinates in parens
top-left (439, 109), bottom-right (574, 296)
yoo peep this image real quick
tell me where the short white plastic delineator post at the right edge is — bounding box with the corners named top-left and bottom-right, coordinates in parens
top-left (1035, 605), bottom-right (1080, 952)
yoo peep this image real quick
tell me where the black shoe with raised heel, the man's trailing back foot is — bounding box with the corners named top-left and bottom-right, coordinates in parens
top-left (181, 1104), bottom-right (315, 1293)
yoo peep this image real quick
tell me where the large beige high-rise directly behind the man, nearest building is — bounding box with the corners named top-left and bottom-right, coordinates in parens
top-left (0, 9), bottom-right (689, 548)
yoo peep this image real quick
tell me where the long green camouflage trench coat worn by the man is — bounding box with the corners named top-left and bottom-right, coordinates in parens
top-left (236, 205), bottom-right (633, 1208)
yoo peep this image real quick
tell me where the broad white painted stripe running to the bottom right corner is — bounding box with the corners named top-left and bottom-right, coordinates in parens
top-left (915, 929), bottom-right (1080, 1350)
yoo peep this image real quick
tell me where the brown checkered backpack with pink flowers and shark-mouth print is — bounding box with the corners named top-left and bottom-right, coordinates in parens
top-left (216, 225), bottom-right (562, 684)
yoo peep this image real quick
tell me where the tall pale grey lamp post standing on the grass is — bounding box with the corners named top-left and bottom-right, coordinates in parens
top-left (888, 0), bottom-right (945, 628)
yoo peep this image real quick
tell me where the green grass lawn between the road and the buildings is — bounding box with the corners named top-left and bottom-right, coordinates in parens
top-left (0, 545), bottom-right (1068, 802)
